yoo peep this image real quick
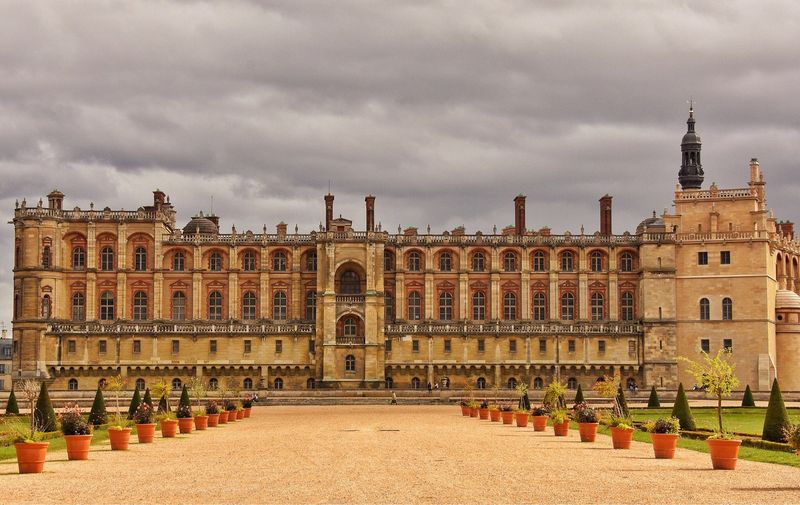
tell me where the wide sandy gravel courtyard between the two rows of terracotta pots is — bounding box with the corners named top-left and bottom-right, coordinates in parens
top-left (0, 405), bottom-right (800, 504)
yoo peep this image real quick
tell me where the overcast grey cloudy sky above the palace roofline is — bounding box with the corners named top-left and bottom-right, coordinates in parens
top-left (0, 0), bottom-right (800, 321)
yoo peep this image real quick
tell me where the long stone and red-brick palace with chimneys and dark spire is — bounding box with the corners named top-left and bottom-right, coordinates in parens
top-left (12, 111), bottom-right (800, 391)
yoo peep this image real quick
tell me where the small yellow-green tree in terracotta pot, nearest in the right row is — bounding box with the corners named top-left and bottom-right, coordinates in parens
top-left (680, 349), bottom-right (742, 470)
